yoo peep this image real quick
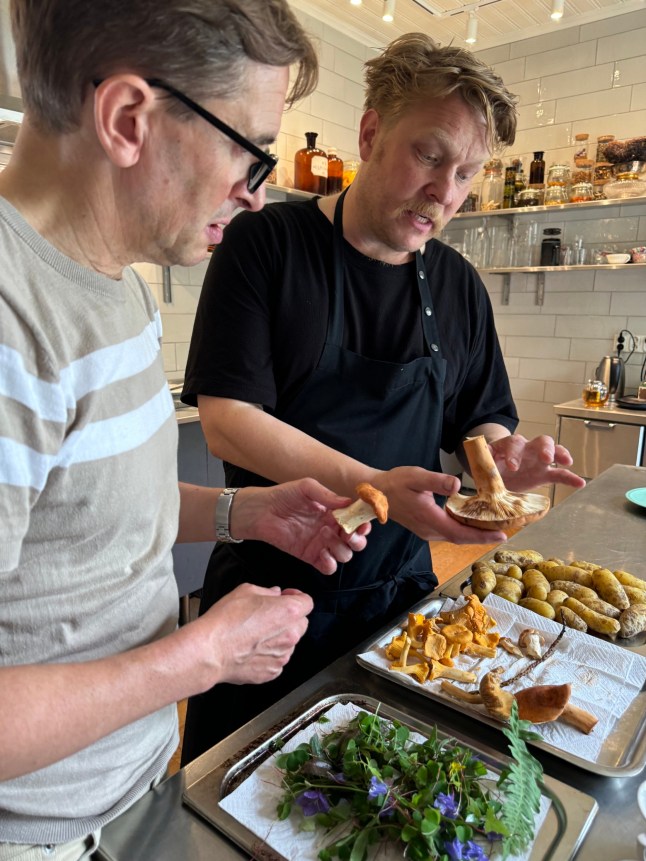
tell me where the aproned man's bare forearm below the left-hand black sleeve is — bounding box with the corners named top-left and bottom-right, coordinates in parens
top-left (198, 395), bottom-right (379, 497)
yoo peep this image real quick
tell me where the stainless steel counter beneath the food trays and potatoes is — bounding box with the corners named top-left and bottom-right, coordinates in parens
top-left (98, 465), bottom-right (646, 861)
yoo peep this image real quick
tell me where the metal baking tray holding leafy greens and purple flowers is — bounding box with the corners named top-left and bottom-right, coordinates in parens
top-left (183, 693), bottom-right (598, 861)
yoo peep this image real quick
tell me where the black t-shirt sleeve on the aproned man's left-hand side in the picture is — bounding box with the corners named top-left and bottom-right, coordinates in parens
top-left (182, 212), bottom-right (281, 408)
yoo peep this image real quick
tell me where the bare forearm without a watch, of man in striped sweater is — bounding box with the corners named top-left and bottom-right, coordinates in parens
top-left (0, 626), bottom-right (210, 780)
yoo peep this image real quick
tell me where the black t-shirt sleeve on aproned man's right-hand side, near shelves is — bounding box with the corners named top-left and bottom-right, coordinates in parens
top-left (442, 252), bottom-right (518, 452)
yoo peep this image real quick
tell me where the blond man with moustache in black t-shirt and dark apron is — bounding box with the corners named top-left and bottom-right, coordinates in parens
top-left (183, 33), bottom-right (583, 761)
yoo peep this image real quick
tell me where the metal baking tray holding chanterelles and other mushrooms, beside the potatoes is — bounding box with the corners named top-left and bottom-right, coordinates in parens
top-left (357, 596), bottom-right (646, 777)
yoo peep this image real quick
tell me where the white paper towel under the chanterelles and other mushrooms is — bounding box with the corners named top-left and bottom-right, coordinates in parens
top-left (359, 595), bottom-right (646, 763)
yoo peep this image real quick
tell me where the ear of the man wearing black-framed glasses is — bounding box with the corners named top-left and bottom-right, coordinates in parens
top-left (94, 75), bottom-right (155, 168)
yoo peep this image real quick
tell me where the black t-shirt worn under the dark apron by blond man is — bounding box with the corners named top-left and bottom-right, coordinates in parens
top-left (182, 194), bottom-right (518, 452)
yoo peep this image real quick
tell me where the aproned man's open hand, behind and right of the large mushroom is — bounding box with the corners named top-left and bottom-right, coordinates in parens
top-left (490, 434), bottom-right (585, 493)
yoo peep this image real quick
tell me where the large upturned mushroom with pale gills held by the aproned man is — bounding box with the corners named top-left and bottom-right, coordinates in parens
top-left (446, 436), bottom-right (550, 529)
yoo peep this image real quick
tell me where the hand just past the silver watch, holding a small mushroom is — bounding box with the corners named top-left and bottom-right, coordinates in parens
top-left (231, 478), bottom-right (370, 585)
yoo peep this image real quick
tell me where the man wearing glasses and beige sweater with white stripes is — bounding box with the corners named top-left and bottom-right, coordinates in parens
top-left (0, 0), bottom-right (366, 861)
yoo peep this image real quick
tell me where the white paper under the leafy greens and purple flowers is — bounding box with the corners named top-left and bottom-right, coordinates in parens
top-left (219, 703), bottom-right (551, 861)
